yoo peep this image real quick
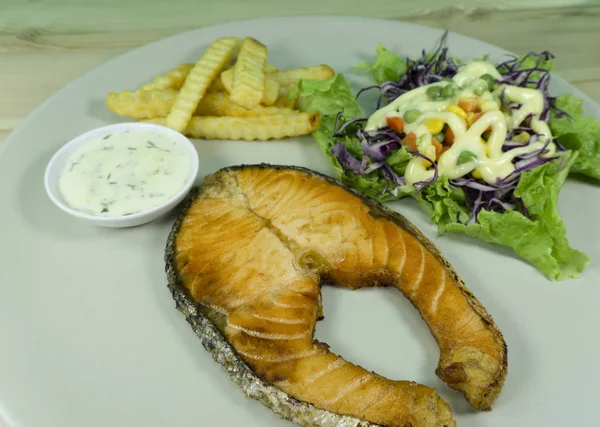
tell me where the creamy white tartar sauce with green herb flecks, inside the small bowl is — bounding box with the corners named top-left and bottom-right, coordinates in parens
top-left (58, 131), bottom-right (192, 216)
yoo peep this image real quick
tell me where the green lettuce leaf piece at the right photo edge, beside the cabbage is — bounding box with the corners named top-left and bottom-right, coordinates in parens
top-left (548, 94), bottom-right (600, 180)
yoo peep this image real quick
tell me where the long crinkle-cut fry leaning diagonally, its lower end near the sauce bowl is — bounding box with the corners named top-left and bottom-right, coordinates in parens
top-left (165, 37), bottom-right (240, 132)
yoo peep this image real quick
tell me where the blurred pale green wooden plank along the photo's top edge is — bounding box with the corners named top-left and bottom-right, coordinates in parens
top-left (0, 0), bottom-right (589, 44)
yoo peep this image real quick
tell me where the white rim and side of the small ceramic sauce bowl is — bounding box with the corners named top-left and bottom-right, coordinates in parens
top-left (44, 122), bottom-right (199, 228)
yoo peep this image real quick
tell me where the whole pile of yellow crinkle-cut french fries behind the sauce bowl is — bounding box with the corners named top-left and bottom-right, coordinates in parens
top-left (105, 33), bottom-right (335, 141)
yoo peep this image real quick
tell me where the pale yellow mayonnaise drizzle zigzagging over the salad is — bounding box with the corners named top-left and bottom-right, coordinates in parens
top-left (365, 61), bottom-right (556, 185)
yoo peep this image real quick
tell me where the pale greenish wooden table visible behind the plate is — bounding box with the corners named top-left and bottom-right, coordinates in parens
top-left (0, 0), bottom-right (600, 142)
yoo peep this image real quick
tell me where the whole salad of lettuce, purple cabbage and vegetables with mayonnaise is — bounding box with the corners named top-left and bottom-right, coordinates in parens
top-left (292, 34), bottom-right (600, 280)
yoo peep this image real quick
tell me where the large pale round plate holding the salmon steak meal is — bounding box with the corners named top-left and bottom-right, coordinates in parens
top-left (0, 17), bottom-right (600, 427)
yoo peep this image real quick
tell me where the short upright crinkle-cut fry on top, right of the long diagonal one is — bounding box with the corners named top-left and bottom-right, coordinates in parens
top-left (230, 37), bottom-right (268, 109)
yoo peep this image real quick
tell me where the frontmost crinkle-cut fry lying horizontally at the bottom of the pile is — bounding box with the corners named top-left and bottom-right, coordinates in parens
top-left (146, 112), bottom-right (321, 141)
